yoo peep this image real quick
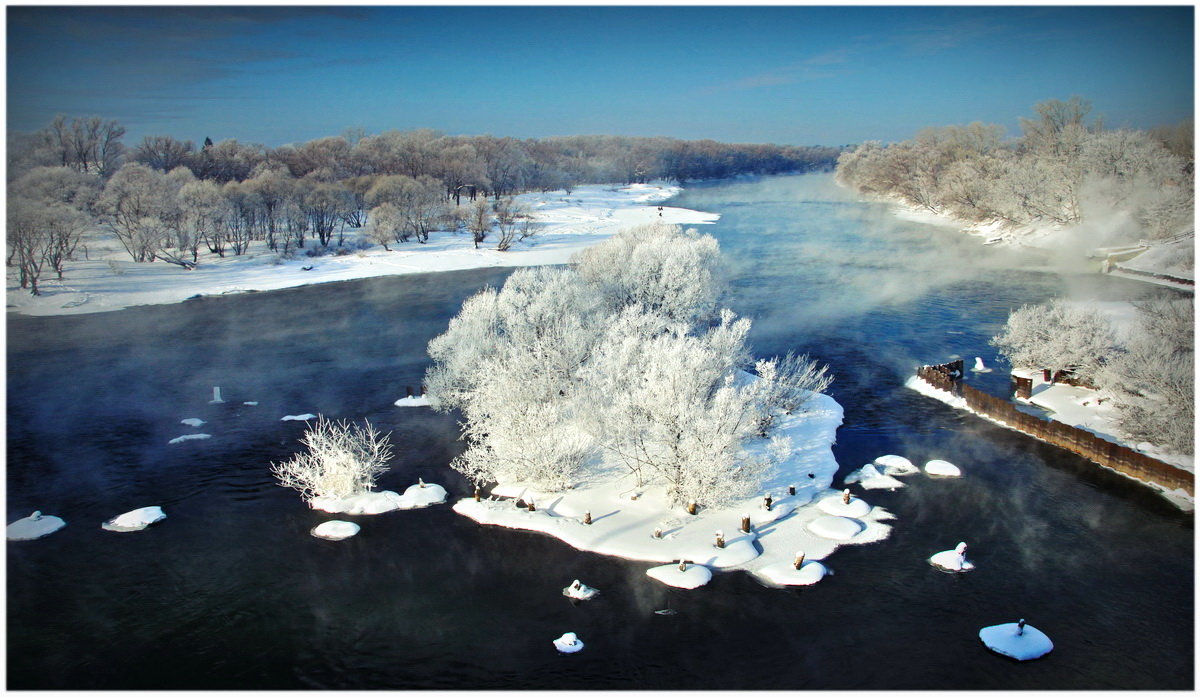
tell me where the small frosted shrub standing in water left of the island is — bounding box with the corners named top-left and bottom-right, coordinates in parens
top-left (271, 416), bottom-right (391, 501)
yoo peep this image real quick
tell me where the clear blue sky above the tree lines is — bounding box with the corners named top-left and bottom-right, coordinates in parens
top-left (7, 6), bottom-right (1194, 146)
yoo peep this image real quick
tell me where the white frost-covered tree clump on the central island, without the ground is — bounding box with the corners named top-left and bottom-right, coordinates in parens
top-left (425, 224), bottom-right (828, 505)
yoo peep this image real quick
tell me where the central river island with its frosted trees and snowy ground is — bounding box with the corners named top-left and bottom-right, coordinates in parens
top-left (425, 226), bottom-right (892, 588)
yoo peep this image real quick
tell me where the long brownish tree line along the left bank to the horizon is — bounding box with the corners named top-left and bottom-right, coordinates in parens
top-left (7, 116), bottom-right (841, 294)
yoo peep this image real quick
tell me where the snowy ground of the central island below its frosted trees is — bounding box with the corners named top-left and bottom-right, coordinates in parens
top-left (454, 395), bottom-right (893, 584)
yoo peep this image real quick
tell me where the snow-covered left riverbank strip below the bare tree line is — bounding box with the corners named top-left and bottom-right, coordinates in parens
top-left (7, 184), bottom-right (718, 316)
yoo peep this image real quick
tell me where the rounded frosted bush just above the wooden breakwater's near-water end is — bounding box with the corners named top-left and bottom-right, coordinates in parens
top-left (991, 299), bottom-right (1116, 380)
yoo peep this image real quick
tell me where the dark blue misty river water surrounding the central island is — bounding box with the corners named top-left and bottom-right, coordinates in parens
top-left (6, 175), bottom-right (1195, 690)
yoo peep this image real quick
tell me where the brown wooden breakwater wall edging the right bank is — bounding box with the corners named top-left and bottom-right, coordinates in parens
top-left (917, 360), bottom-right (1195, 495)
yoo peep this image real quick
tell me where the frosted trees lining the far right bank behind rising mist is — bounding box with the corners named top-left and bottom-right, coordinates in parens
top-left (836, 97), bottom-right (1195, 240)
